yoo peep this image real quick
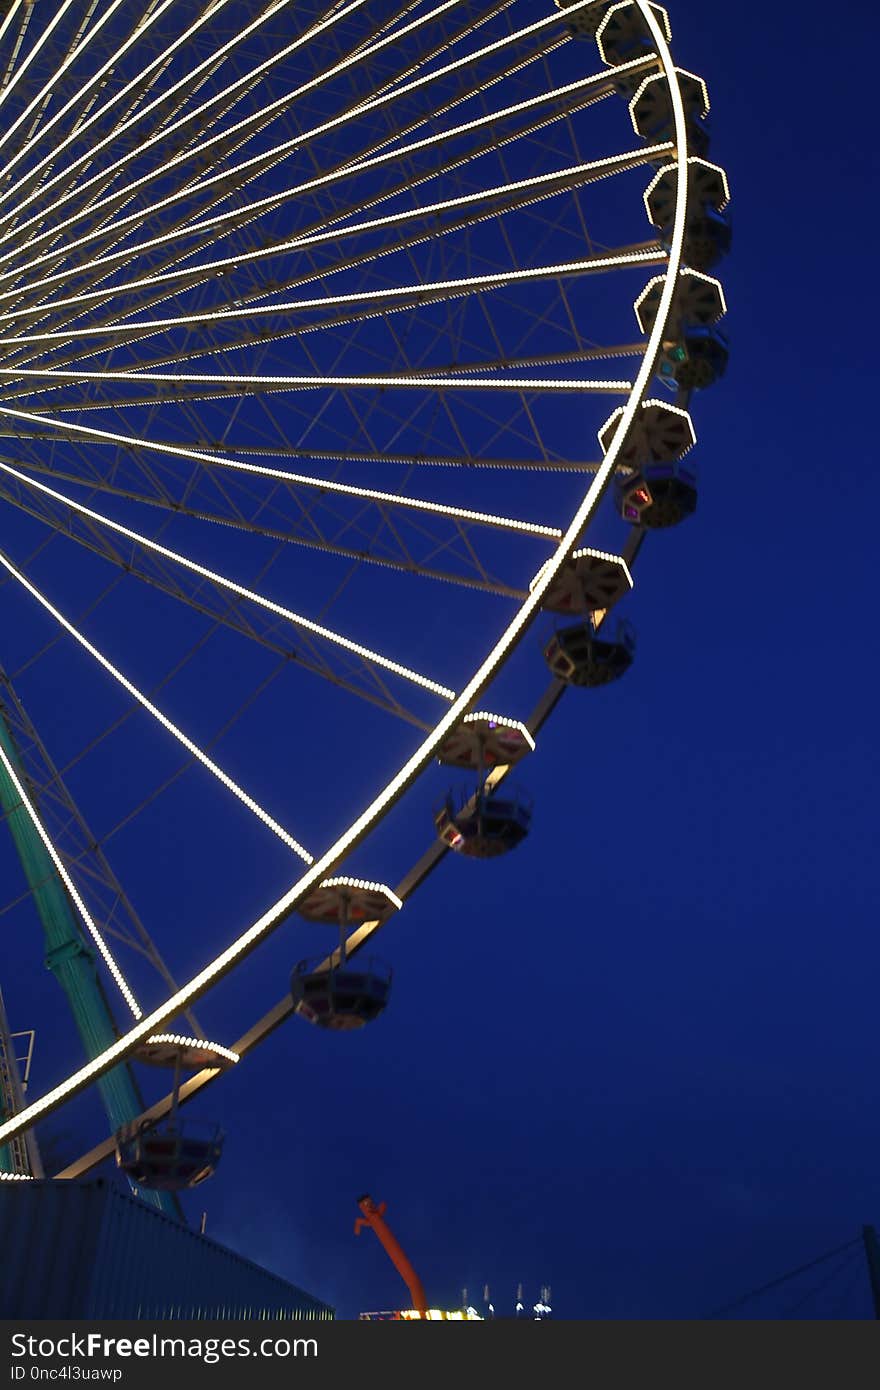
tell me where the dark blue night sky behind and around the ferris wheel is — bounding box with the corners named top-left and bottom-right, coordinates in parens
top-left (0, 0), bottom-right (880, 1319)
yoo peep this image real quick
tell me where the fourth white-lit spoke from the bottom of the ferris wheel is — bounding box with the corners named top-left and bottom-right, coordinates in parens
top-left (0, 406), bottom-right (562, 541)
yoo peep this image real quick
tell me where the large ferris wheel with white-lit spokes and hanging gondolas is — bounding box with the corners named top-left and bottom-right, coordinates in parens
top-left (0, 0), bottom-right (730, 1209)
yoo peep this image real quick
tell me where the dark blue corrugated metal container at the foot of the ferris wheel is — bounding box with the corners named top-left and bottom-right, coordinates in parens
top-left (0, 1177), bottom-right (334, 1319)
